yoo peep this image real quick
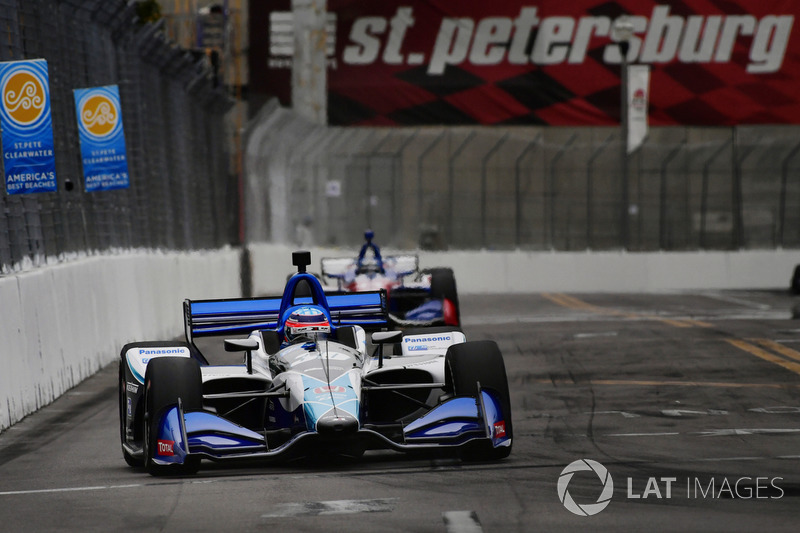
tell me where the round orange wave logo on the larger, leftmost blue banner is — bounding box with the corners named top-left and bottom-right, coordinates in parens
top-left (2, 65), bottom-right (47, 126)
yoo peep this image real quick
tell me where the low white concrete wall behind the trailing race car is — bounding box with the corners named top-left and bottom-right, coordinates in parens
top-left (250, 244), bottom-right (800, 294)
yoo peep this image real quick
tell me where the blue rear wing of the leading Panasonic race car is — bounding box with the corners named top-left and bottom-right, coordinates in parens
top-left (183, 290), bottom-right (388, 344)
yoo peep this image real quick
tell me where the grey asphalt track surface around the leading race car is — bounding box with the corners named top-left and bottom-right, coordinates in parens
top-left (0, 291), bottom-right (800, 532)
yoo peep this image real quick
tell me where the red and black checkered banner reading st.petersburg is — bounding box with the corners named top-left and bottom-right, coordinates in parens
top-left (250, 0), bottom-right (800, 126)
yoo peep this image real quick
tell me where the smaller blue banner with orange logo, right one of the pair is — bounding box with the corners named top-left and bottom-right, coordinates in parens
top-left (73, 85), bottom-right (130, 192)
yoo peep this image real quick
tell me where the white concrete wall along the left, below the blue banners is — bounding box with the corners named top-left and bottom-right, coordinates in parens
top-left (0, 249), bottom-right (241, 430)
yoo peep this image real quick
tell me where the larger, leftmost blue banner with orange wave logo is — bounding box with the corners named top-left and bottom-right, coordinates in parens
top-left (0, 59), bottom-right (57, 194)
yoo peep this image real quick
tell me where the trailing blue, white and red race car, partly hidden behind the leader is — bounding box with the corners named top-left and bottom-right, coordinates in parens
top-left (321, 230), bottom-right (461, 327)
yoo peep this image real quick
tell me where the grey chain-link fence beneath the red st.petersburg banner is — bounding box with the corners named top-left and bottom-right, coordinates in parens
top-left (245, 102), bottom-right (800, 255)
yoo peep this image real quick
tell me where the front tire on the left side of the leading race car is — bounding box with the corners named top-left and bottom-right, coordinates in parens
top-left (142, 357), bottom-right (203, 476)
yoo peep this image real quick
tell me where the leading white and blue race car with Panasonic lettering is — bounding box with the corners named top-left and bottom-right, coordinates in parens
top-left (119, 252), bottom-right (513, 475)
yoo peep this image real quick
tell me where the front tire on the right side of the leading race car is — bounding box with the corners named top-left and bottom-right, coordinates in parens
top-left (445, 341), bottom-right (514, 460)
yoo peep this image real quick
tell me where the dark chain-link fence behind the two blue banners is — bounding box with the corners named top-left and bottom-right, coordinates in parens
top-left (0, 0), bottom-right (239, 273)
